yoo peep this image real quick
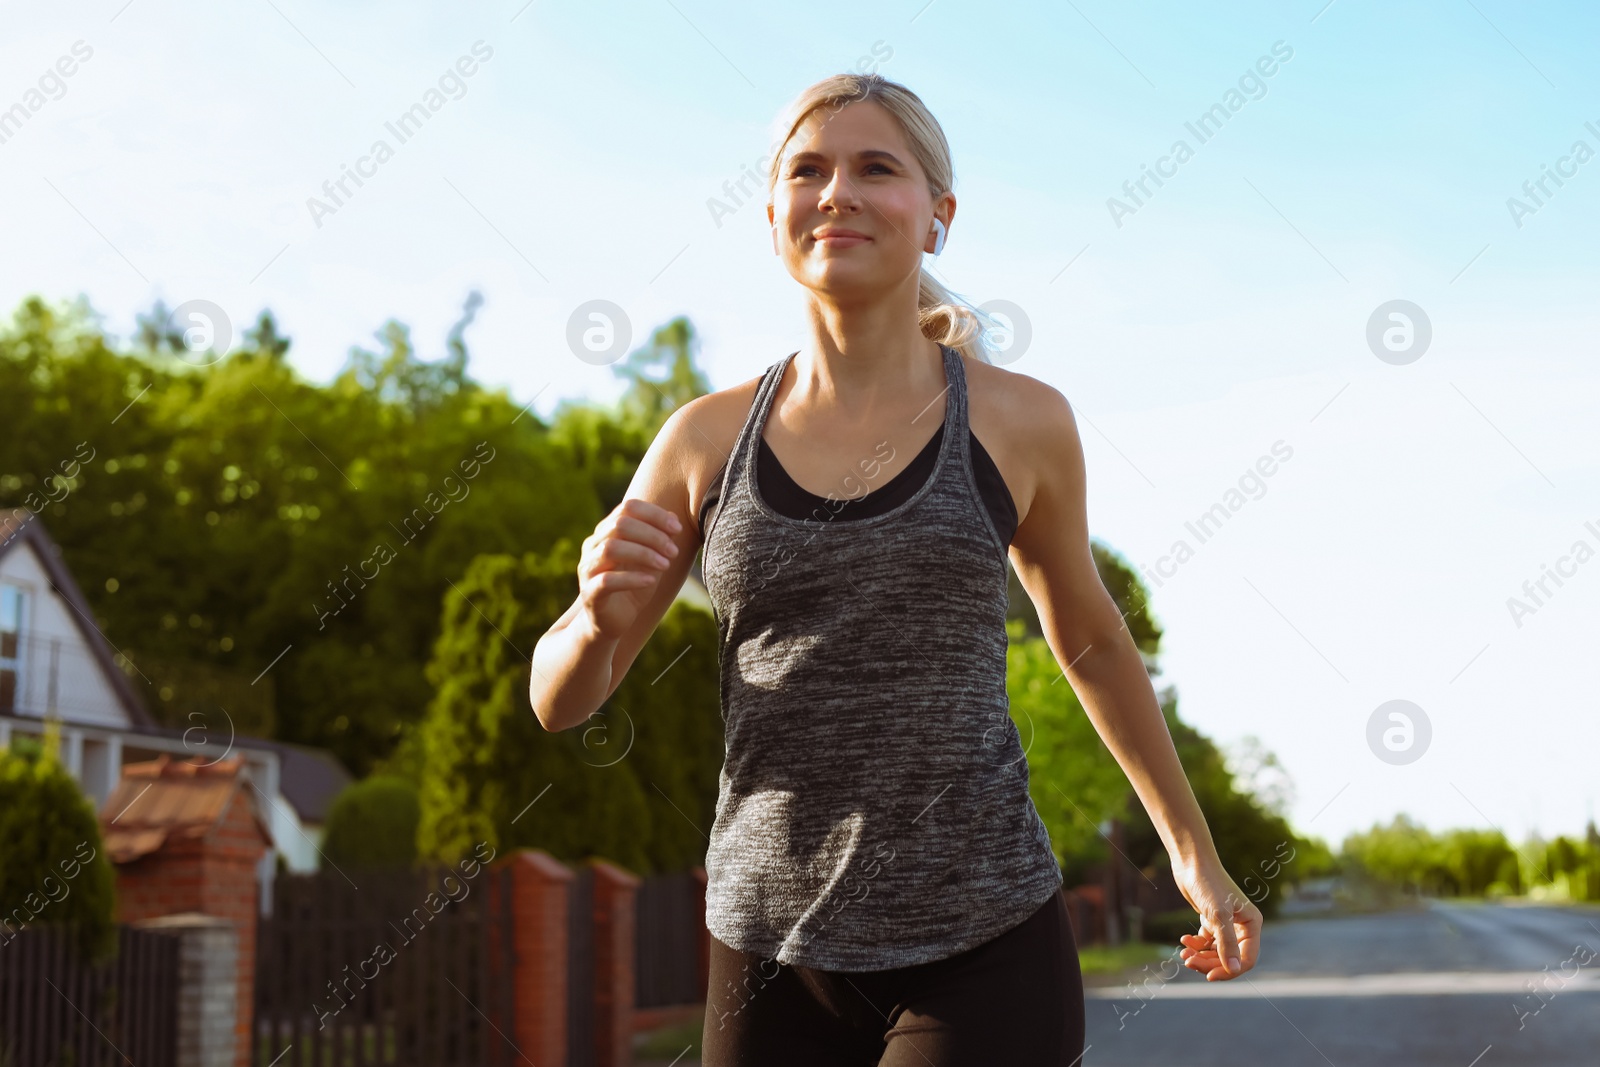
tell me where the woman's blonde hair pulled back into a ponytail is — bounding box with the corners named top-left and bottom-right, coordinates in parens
top-left (766, 74), bottom-right (995, 363)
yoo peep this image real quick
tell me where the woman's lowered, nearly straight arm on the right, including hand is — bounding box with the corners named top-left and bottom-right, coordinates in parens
top-left (1011, 379), bottom-right (1262, 981)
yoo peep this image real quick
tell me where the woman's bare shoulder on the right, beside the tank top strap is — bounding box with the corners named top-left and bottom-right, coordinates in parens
top-left (962, 358), bottom-right (1072, 523)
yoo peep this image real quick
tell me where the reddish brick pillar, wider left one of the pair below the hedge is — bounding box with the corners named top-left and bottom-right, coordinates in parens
top-left (496, 848), bottom-right (573, 1065)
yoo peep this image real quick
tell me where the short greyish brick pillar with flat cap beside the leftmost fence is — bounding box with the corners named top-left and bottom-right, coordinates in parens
top-left (133, 912), bottom-right (238, 1067)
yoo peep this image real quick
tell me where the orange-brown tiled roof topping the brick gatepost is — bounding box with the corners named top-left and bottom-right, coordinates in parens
top-left (99, 753), bottom-right (272, 864)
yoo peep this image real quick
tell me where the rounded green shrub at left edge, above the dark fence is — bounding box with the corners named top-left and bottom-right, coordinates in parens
top-left (0, 723), bottom-right (117, 958)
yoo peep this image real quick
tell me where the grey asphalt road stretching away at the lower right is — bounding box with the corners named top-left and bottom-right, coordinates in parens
top-left (1083, 902), bottom-right (1600, 1067)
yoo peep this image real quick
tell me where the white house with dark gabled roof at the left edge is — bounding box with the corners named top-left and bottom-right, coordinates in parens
top-left (0, 509), bottom-right (350, 902)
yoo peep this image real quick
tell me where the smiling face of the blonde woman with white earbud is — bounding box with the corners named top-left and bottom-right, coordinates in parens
top-left (766, 101), bottom-right (955, 299)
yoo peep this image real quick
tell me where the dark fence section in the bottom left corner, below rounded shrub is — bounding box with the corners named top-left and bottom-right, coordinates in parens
top-left (0, 926), bottom-right (179, 1067)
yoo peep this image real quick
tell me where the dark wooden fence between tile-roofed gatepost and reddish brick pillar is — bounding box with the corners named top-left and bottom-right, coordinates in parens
top-left (254, 867), bottom-right (518, 1067)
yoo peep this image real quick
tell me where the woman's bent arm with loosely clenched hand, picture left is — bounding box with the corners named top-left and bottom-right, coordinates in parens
top-left (528, 403), bottom-right (706, 733)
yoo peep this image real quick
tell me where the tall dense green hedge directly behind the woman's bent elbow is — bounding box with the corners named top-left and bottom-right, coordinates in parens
top-left (418, 539), bottom-right (723, 873)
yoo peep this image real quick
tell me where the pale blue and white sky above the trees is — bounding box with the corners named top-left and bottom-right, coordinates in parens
top-left (0, 0), bottom-right (1600, 843)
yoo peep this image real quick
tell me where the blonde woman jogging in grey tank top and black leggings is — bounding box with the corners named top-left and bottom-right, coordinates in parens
top-left (530, 75), bottom-right (1261, 1067)
